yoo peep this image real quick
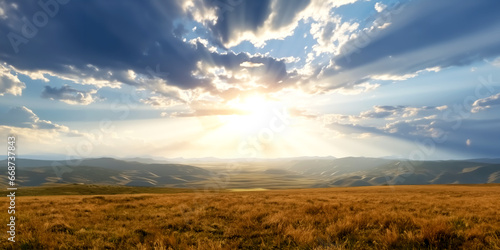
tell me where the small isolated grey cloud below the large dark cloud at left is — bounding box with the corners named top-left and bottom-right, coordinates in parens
top-left (42, 85), bottom-right (100, 105)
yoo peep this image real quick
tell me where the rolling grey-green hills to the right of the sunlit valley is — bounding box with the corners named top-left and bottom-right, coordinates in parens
top-left (288, 157), bottom-right (500, 187)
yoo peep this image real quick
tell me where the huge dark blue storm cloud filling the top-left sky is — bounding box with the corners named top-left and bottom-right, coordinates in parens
top-left (0, 0), bottom-right (286, 93)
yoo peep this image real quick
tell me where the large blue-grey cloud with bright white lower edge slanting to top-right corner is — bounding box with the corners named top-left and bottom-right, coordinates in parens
top-left (311, 0), bottom-right (500, 90)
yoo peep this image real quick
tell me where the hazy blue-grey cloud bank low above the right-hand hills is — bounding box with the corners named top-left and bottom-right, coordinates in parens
top-left (319, 106), bottom-right (500, 157)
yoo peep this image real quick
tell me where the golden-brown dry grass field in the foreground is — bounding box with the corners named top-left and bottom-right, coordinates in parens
top-left (0, 185), bottom-right (500, 249)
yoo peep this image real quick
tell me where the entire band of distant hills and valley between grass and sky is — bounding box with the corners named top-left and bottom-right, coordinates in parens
top-left (0, 157), bottom-right (500, 189)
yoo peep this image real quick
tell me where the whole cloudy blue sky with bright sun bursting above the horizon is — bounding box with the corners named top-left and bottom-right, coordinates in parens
top-left (0, 0), bottom-right (500, 160)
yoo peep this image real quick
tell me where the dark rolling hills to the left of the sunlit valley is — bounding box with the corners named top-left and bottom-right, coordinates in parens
top-left (0, 158), bottom-right (210, 187)
